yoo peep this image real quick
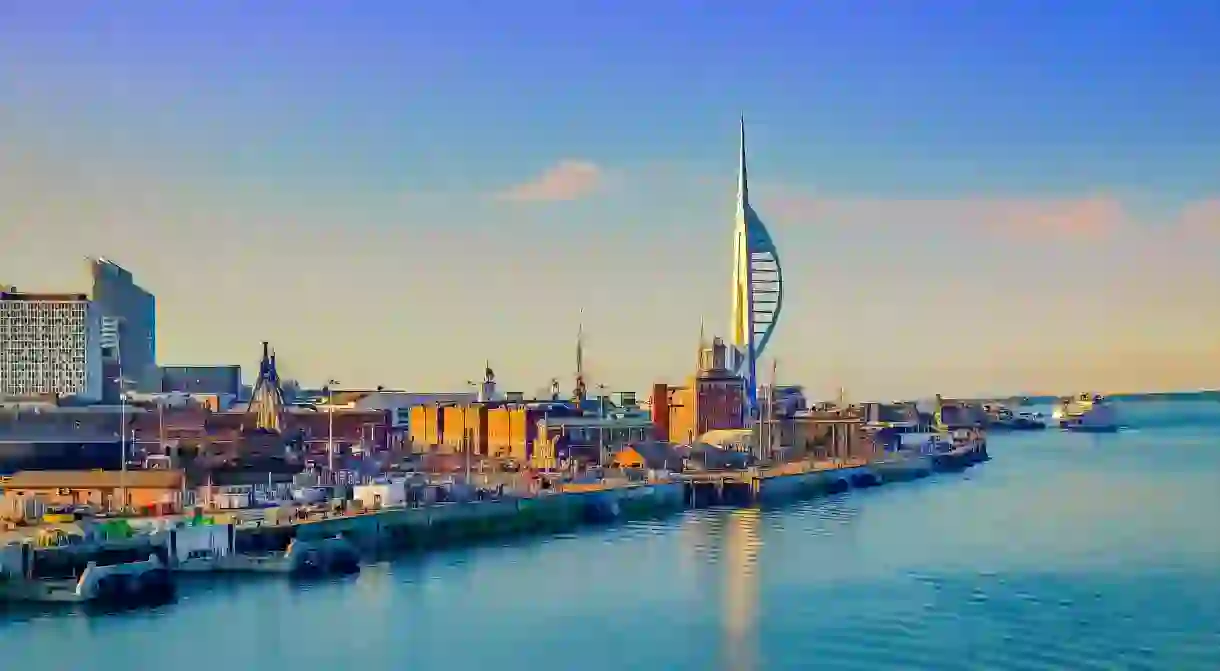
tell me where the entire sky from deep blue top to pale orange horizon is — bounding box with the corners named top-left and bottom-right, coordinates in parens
top-left (0, 0), bottom-right (1220, 398)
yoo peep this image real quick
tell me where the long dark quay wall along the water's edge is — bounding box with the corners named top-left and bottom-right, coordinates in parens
top-left (0, 443), bottom-right (988, 597)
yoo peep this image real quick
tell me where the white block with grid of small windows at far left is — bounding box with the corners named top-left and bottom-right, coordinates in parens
top-left (0, 292), bottom-right (102, 401)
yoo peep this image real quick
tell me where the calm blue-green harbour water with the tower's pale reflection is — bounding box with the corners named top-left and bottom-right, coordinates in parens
top-left (0, 403), bottom-right (1220, 671)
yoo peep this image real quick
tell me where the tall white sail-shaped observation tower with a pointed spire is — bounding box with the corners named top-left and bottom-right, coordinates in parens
top-left (730, 118), bottom-right (783, 412)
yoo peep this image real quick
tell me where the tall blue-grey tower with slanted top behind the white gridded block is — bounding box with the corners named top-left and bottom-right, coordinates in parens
top-left (88, 257), bottom-right (161, 392)
